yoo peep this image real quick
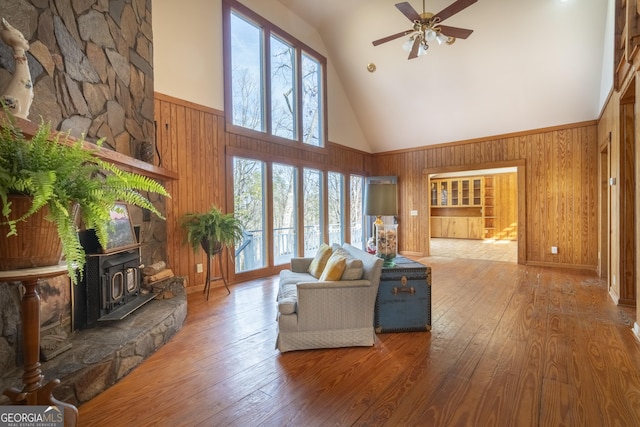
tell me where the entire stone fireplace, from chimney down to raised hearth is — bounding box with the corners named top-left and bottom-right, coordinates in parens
top-left (0, 0), bottom-right (186, 404)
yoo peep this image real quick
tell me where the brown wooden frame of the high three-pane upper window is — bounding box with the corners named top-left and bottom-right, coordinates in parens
top-left (222, 0), bottom-right (328, 151)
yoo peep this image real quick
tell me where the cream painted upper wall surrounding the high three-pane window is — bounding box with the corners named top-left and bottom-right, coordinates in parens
top-left (152, 0), bottom-right (371, 152)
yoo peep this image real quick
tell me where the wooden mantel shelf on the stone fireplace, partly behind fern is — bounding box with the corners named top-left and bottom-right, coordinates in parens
top-left (0, 112), bottom-right (178, 180)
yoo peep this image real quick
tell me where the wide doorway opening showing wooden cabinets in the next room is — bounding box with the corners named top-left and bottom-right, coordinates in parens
top-left (426, 162), bottom-right (525, 264)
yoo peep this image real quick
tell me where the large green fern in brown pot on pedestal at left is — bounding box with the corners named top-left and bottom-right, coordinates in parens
top-left (0, 111), bottom-right (169, 283)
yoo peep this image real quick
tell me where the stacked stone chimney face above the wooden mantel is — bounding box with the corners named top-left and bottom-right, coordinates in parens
top-left (0, 0), bottom-right (155, 157)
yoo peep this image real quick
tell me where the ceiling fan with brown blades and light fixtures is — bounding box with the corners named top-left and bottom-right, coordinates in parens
top-left (373, 0), bottom-right (478, 59)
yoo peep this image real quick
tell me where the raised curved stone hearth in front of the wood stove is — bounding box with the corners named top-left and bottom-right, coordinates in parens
top-left (0, 278), bottom-right (187, 406)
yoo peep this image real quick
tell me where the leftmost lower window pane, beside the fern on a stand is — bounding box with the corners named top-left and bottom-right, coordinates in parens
top-left (233, 157), bottom-right (266, 273)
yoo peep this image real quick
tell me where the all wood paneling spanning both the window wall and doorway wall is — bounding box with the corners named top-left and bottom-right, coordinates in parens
top-left (155, 94), bottom-right (598, 290)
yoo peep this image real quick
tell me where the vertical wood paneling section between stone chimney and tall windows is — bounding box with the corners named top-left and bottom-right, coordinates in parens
top-left (155, 94), bottom-right (225, 288)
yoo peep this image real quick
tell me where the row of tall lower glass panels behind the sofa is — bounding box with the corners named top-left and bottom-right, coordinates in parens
top-left (231, 157), bottom-right (364, 274)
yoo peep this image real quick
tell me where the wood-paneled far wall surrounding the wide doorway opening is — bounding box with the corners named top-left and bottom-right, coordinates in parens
top-left (373, 121), bottom-right (598, 270)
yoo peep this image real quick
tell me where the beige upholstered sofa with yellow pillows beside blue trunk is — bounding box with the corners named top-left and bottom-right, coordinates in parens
top-left (276, 243), bottom-right (383, 352)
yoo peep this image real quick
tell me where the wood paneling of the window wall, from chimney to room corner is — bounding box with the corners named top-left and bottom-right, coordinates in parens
top-left (155, 93), bottom-right (371, 291)
